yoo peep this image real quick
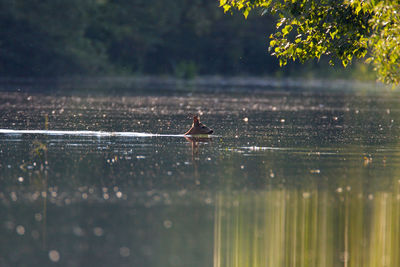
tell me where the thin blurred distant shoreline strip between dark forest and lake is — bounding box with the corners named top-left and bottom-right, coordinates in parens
top-left (0, 76), bottom-right (391, 94)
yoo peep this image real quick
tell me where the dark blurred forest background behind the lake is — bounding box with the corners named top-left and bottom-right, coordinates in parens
top-left (0, 0), bottom-right (374, 78)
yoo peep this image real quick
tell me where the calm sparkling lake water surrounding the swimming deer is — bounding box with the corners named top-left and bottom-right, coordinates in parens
top-left (0, 87), bottom-right (400, 267)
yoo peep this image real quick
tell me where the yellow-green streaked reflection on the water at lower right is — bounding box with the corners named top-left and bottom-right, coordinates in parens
top-left (214, 185), bottom-right (400, 267)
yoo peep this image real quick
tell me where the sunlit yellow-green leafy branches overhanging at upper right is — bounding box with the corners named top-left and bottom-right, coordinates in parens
top-left (220, 0), bottom-right (400, 84)
